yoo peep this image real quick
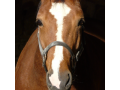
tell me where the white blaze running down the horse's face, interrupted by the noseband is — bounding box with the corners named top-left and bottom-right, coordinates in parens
top-left (49, 3), bottom-right (71, 89)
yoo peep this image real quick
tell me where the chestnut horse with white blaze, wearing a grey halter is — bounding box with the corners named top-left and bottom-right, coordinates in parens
top-left (15, 0), bottom-right (84, 90)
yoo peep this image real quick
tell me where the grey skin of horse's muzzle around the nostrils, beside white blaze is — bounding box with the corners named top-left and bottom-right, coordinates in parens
top-left (46, 70), bottom-right (72, 90)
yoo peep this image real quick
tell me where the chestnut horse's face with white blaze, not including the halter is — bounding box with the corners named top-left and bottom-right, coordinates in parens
top-left (36, 0), bottom-right (84, 90)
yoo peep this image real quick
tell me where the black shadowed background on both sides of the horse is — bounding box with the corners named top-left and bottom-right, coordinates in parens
top-left (15, 0), bottom-right (105, 90)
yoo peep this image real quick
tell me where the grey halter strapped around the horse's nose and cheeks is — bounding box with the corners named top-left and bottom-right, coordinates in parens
top-left (37, 26), bottom-right (84, 72)
